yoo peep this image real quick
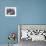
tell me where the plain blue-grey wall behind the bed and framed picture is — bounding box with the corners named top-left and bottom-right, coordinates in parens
top-left (0, 0), bottom-right (46, 43)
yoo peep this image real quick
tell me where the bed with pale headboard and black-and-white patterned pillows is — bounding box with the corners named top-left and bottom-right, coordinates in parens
top-left (18, 24), bottom-right (46, 46)
